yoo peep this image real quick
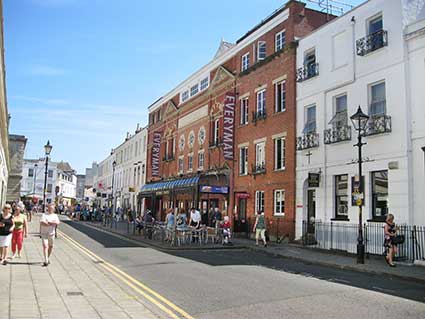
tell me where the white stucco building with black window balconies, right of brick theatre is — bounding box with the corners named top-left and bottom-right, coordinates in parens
top-left (296, 0), bottom-right (425, 238)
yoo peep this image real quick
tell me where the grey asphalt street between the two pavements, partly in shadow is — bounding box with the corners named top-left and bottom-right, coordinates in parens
top-left (61, 221), bottom-right (425, 319)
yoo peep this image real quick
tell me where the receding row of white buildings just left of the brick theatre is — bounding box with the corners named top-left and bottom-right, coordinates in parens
top-left (94, 127), bottom-right (147, 211)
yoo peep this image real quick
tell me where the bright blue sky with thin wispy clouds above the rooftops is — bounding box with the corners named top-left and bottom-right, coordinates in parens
top-left (3, 0), bottom-right (363, 173)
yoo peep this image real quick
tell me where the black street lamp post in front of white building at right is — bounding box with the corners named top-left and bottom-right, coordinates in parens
top-left (350, 105), bottom-right (369, 264)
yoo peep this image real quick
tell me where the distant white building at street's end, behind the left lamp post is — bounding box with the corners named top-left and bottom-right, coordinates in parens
top-left (21, 158), bottom-right (77, 206)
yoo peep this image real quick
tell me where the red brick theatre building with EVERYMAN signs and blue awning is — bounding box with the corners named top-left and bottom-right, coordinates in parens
top-left (139, 1), bottom-right (328, 237)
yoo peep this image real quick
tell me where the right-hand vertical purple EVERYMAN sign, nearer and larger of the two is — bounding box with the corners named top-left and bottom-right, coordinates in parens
top-left (223, 93), bottom-right (235, 160)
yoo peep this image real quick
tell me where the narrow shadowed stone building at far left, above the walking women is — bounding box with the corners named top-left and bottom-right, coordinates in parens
top-left (7, 134), bottom-right (27, 201)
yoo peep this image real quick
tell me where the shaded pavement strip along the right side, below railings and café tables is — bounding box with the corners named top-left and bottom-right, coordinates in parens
top-left (84, 222), bottom-right (425, 283)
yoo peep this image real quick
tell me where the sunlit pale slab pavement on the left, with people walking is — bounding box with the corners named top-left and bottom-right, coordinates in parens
top-left (0, 216), bottom-right (172, 319)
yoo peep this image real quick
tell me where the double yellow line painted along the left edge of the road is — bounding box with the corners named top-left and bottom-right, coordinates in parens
top-left (58, 230), bottom-right (194, 319)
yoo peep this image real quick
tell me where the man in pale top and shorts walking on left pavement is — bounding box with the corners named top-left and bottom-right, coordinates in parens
top-left (40, 204), bottom-right (60, 267)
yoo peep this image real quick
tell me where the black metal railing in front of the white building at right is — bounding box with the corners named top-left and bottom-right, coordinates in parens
top-left (302, 221), bottom-right (425, 262)
